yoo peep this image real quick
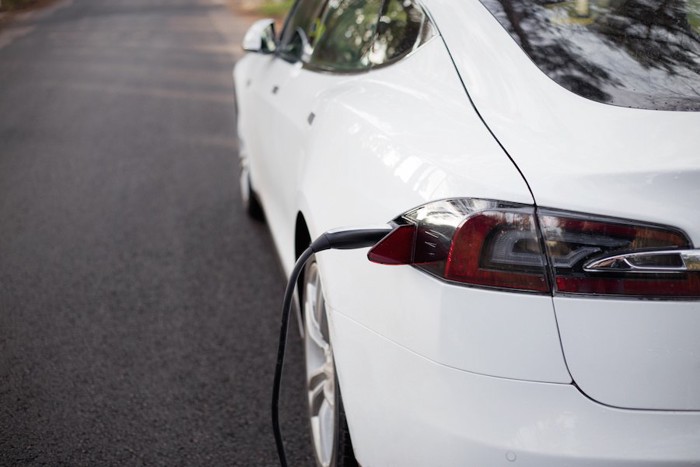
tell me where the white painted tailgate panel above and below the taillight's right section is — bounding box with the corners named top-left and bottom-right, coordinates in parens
top-left (431, 0), bottom-right (700, 410)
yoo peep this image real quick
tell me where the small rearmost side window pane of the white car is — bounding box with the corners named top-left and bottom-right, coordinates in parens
top-left (371, 0), bottom-right (428, 65)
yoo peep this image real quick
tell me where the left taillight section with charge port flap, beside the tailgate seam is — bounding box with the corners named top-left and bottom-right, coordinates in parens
top-left (369, 199), bottom-right (550, 293)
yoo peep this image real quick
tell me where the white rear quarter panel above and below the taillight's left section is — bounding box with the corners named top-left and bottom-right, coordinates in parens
top-left (290, 40), bottom-right (570, 382)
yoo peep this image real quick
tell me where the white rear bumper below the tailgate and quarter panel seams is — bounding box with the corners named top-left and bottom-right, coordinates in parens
top-left (332, 311), bottom-right (700, 467)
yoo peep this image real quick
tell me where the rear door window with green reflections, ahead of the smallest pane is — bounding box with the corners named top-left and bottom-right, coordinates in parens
top-left (310, 0), bottom-right (382, 71)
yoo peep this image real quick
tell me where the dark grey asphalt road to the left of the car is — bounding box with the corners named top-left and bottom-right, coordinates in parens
top-left (0, 0), bottom-right (311, 466)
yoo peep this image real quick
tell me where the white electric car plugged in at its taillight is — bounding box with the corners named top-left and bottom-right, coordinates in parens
top-left (234, 0), bottom-right (700, 467)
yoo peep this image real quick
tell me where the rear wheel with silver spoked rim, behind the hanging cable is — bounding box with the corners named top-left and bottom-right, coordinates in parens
top-left (302, 259), bottom-right (357, 467)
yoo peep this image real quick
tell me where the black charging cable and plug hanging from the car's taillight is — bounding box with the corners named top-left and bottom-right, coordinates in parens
top-left (272, 226), bottom-right (392, 467)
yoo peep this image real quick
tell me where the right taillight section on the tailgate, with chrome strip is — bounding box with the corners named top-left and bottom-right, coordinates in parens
top-left (539, 210), bottom-right (700, 298)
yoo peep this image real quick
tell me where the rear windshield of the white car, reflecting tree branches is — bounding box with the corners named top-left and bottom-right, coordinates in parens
top-left (481, 0), bottom-right (700, 111)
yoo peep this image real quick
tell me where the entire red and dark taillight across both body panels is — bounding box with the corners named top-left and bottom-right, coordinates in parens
top-left (369, 199), bottom-right (700, 298)
